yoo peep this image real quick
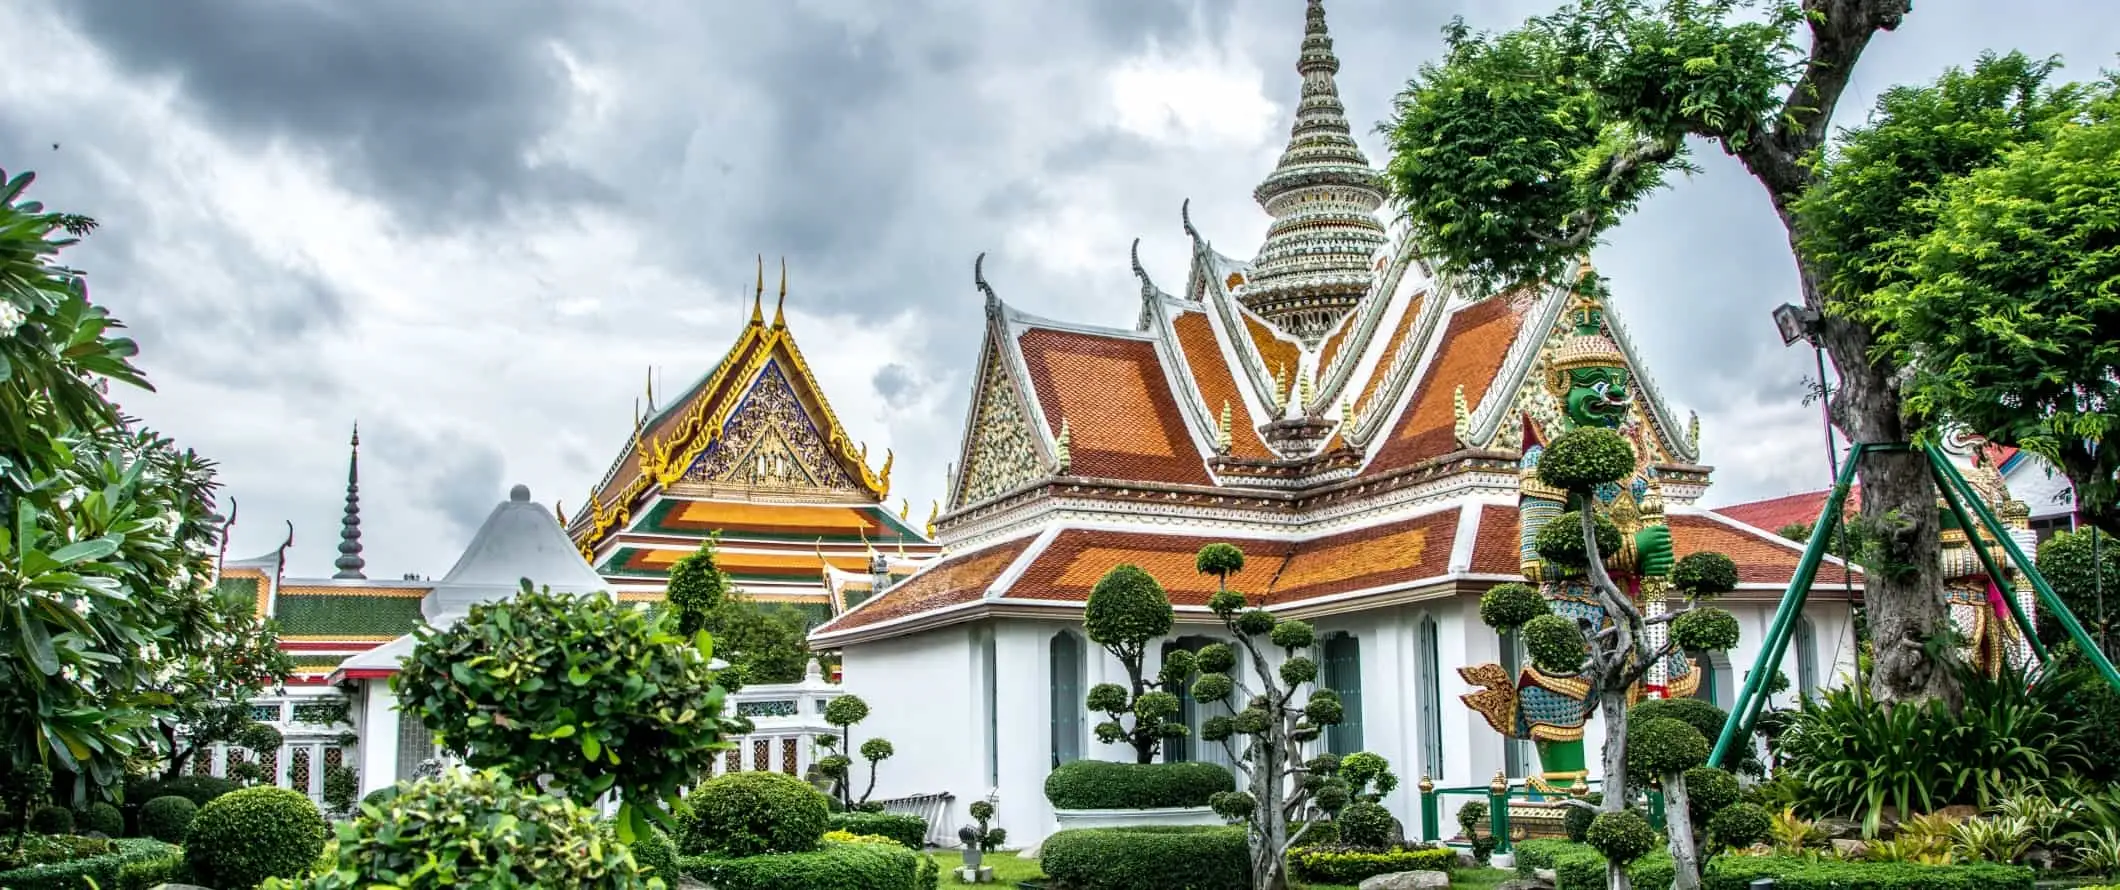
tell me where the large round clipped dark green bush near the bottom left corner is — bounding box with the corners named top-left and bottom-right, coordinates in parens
top-left (184, 786), bottom-right (331, 888)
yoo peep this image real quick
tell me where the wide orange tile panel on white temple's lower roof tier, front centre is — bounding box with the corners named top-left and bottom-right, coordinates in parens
top-left (1007, 509), bottom-right (1459, 606)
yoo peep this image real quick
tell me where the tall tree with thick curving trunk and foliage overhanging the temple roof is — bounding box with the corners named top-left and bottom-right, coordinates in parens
top-left (1386, 0), bottom-right (1957, 701)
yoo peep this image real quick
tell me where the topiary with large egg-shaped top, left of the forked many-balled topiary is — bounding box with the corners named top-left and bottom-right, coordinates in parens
top-left (1081, 564), bottom-right (1194, 763)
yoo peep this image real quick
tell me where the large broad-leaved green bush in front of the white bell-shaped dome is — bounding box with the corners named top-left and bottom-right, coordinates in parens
top-left (390, 581), bottom-right (734, 837)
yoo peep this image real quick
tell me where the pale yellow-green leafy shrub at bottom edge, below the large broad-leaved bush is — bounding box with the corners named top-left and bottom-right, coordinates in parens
top-left (273, 769), bottom-right (668, 890)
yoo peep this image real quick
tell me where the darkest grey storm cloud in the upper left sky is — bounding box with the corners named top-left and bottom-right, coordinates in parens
top-left (55, 0), bottom-right (604, 225)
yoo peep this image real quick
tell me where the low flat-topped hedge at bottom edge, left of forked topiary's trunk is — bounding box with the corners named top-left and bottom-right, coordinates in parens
top-left (1039, 822), bottom-right (1251, 890)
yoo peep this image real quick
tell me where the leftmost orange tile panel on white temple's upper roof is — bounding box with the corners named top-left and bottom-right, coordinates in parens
top-left (1018, 328), bottom-right (1221, 485)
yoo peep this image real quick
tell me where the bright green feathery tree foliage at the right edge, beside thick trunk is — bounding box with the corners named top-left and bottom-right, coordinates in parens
top-left (1796, 53), bottom-right (2120, 534)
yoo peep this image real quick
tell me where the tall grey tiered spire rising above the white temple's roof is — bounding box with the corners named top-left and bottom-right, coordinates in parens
top-left (1236, 0), bottom-right (1384, 345)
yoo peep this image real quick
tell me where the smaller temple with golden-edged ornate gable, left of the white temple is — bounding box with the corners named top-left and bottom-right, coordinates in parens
top-left (566, 263), bottom-right (939, 623)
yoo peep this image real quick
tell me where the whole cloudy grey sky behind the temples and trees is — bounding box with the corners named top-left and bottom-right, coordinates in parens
top-left (0, 0), bottom-right (2120, 576)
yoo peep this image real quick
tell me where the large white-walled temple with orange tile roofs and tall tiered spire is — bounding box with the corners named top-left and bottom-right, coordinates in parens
top-left (812, 0), bottom-right (1859, 843)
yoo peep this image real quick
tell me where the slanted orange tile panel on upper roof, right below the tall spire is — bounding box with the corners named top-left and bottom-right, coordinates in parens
top-left (1367, 297), bottom-right (1524, 473)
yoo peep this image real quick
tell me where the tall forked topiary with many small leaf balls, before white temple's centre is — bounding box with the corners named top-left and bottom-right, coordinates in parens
top-left (1191, 545), bottom-right (1339, 890)
